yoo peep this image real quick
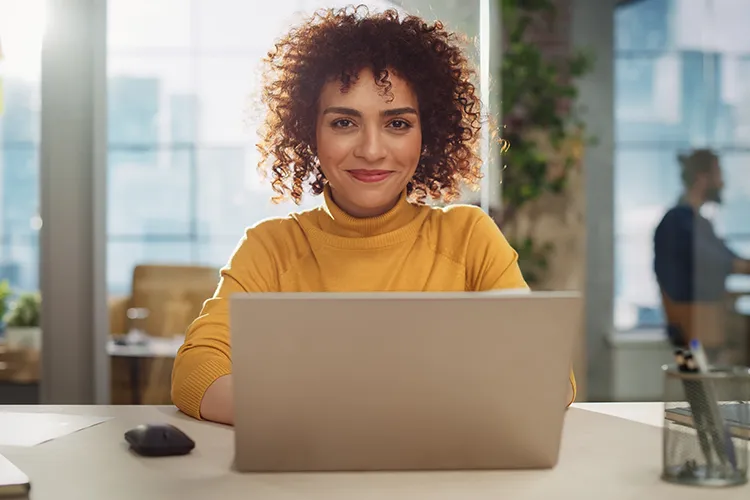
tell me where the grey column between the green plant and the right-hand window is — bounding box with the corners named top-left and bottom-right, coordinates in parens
top-left (570, 0), bottom-right (617, 401)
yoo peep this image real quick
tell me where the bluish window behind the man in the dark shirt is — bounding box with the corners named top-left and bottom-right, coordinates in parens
top-left (615, 0), bottom-right (750, 330)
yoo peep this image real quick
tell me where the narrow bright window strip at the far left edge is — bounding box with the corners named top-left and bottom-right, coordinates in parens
top-left (0, 0), bottom-right (45, 292)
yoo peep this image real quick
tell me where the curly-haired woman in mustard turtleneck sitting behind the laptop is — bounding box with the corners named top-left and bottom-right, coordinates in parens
top-left (172, 5), bottom-right (575, 424)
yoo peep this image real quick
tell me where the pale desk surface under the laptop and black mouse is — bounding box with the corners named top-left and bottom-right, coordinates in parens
top-left (0, 403), bottom-right (750, 500)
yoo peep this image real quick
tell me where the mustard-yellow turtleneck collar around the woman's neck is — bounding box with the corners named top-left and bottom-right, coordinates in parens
top-left (319, 184), bottom-right (420, 238)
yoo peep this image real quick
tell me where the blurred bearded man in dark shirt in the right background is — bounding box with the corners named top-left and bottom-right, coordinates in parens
top-left (654, 149), bottom-right (750, 345)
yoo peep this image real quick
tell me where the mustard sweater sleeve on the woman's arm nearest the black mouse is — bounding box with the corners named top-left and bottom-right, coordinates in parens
top-left (172, 229), bottom-right (276, 419)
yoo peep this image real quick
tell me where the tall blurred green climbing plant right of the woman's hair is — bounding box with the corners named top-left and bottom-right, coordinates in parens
top-left (498, 0), bottom-right (594, 283)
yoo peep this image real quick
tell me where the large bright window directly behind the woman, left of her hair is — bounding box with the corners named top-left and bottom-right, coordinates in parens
top-left (107, 0), bottom-right (402, 294)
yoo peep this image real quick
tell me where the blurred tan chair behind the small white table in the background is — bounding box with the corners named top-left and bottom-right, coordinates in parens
top-left (109, 265), bottom-right (219, 404)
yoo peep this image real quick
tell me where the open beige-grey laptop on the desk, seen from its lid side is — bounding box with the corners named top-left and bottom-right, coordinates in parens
top-left (230, 291), bottom-right (582, 472)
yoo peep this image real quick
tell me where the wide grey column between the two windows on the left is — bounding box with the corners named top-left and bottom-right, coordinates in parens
top-left (40, 0), bottom-right (109, 404)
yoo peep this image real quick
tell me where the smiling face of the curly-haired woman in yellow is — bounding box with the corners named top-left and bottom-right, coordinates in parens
top-left (316, 70), bottom-right (422, 217)
